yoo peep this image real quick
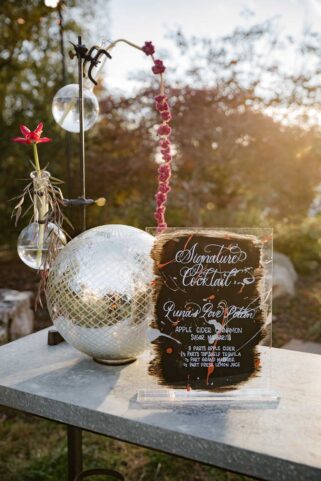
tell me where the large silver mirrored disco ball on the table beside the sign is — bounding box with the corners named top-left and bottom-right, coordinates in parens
top-left (46, 225), bottom-right (154, 364)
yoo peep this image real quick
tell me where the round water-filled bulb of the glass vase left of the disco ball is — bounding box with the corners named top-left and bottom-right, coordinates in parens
top-left (17, 222), bottom-right (67, 270)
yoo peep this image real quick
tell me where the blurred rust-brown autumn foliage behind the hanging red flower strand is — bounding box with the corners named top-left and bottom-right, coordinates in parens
top-left (87, 83), bottom-right (321, 227)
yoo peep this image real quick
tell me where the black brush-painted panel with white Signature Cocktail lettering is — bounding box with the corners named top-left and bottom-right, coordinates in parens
top-left (149, 229), bottom-right (265, 390)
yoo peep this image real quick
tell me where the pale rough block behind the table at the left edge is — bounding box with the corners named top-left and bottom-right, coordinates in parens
top-left (0, 289), bottom-right (34, 344)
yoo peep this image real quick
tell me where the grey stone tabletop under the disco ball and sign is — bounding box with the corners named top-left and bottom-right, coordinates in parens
top-left (0, 330), bottom-right (321, 481)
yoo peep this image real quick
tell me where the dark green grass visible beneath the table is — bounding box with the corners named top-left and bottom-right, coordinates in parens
top-left (0, 409), bottom-right (255, 481)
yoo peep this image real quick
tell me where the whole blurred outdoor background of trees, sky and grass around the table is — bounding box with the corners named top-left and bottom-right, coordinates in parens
top-left (0, 0), bottom-right (321, 481)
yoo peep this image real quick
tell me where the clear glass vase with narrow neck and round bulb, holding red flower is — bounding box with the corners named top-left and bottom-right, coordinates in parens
top-left (17, 170), bottom-right (66, 270)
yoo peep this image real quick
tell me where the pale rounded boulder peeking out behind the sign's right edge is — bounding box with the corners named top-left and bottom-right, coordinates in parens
top-left (273, 252), bottom-right (298, 299)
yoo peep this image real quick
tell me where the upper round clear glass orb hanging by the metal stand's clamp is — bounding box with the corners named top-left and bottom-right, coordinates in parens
top-left (52, 84), bottom-right (99, 132)
